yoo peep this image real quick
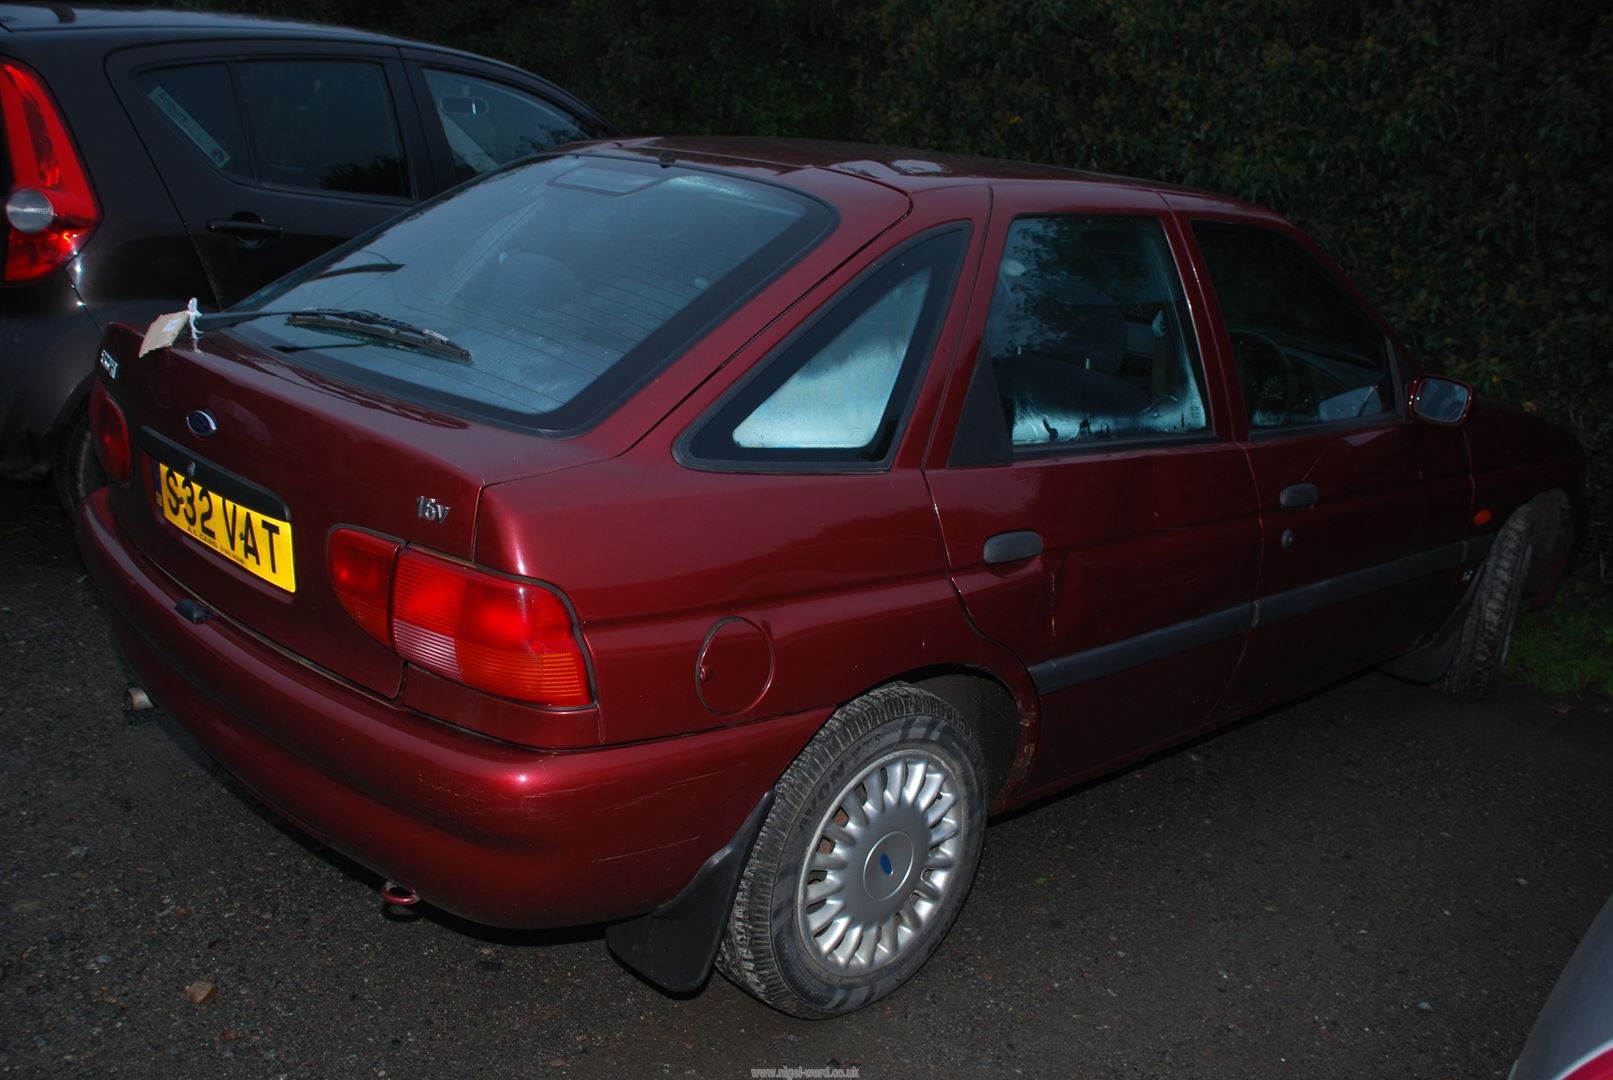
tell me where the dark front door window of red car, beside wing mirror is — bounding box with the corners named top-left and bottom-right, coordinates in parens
top-left (1194, 221), bottom-right (1394, 430)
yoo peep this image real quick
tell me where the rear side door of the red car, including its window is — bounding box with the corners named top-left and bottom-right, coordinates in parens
top-left (926, 184), bottom-right (1258, 790)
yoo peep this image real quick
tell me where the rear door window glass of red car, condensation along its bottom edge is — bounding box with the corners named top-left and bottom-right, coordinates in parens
top-left (982, 214), bottom-right (1210, 448)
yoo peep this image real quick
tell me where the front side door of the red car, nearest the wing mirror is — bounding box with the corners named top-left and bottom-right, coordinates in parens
top-left (1189, 206), bottom-right (1471, 711)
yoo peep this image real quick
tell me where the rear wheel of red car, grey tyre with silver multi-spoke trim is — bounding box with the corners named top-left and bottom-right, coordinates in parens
top-left (716, 683), bottom-right (986, 1019)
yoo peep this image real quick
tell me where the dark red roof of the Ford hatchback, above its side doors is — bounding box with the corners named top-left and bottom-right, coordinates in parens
top-left (615, 135), bottom-right (1232, 210)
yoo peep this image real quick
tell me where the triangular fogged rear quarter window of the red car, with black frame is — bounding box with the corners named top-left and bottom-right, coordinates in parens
top-left (689, 227), bottom-right (968, 464)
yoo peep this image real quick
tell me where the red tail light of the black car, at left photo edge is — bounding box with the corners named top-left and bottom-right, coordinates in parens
top-left (0, 60), bottom-right (100, 282)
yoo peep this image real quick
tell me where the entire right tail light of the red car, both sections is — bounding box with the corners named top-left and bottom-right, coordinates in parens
top-left (329, 529), bottom-right (594, 708)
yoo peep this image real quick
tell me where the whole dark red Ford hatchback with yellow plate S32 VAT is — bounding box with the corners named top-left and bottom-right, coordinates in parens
top-left (79, 140), bottom-right (1584, 1017)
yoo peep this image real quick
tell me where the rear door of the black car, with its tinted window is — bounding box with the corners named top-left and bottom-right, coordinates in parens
top-left (106, 39), bottom-right (434, 306)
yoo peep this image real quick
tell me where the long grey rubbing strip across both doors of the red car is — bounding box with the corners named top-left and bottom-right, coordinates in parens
top-left (1031, 534), bottom-right (1495, 693)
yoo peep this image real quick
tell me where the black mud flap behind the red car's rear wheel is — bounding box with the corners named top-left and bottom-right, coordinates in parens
top-left (605, 790), bottom-right (773, 993)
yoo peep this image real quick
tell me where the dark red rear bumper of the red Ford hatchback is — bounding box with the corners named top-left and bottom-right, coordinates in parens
top-left (79, 492), bottom-right (827, 927)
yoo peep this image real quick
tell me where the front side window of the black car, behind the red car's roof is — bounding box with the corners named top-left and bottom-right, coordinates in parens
top-left (426, 68), bottom-right (589, 181)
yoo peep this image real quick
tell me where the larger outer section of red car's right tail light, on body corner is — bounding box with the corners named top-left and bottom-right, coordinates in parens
top-left (392, 550), bottom-right (592, 708)
